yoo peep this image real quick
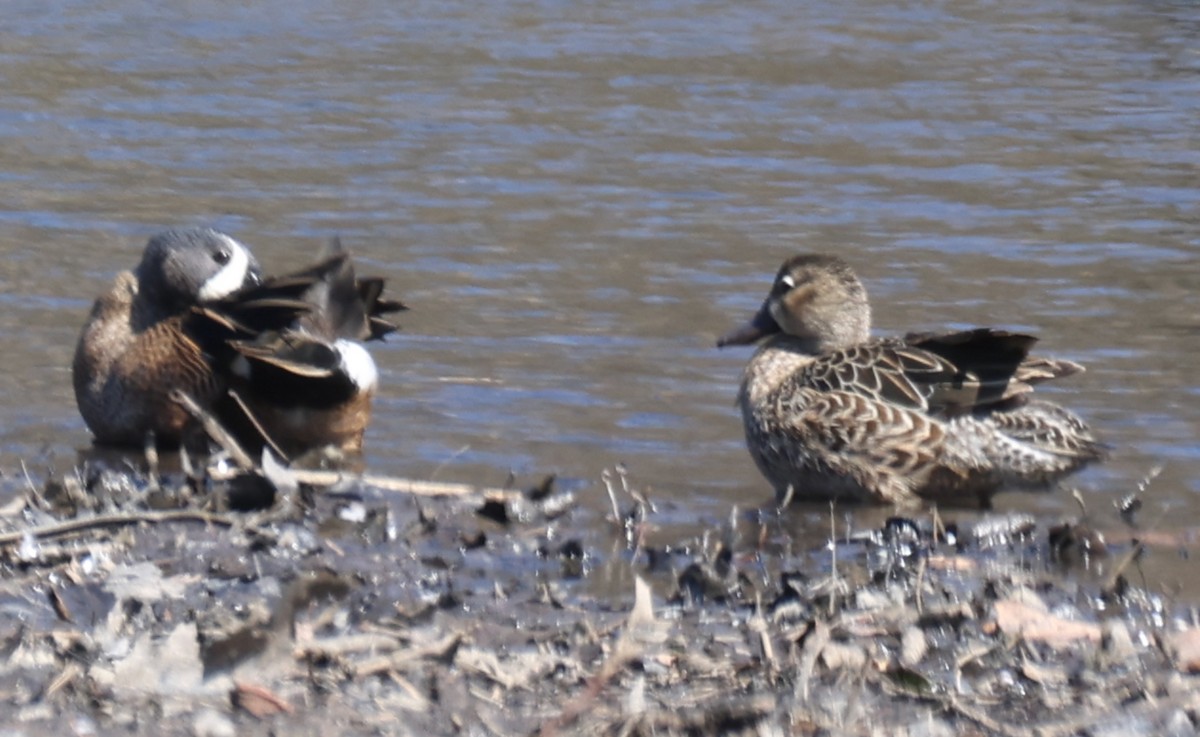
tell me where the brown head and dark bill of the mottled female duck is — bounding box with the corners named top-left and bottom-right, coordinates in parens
top-left (716, 253), bottom-right (871, 354)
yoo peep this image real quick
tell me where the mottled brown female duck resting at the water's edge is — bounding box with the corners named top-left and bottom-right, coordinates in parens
top-left (716, 253), bottom-right (1106, 508)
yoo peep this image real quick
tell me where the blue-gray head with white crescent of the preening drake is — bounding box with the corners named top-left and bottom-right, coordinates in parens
top-left (136, 228), bottom-right (262, 310)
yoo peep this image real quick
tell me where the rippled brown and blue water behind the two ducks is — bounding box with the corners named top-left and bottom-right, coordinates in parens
top-left (0, 0), bottom-right (1200, 577)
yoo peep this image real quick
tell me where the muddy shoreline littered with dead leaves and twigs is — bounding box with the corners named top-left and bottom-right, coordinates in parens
top-left (0, 459), bottom-right (1200, 736)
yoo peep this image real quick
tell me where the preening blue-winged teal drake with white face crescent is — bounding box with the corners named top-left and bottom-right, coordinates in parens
top-left (73, 228), bottom-right (403, 455)
